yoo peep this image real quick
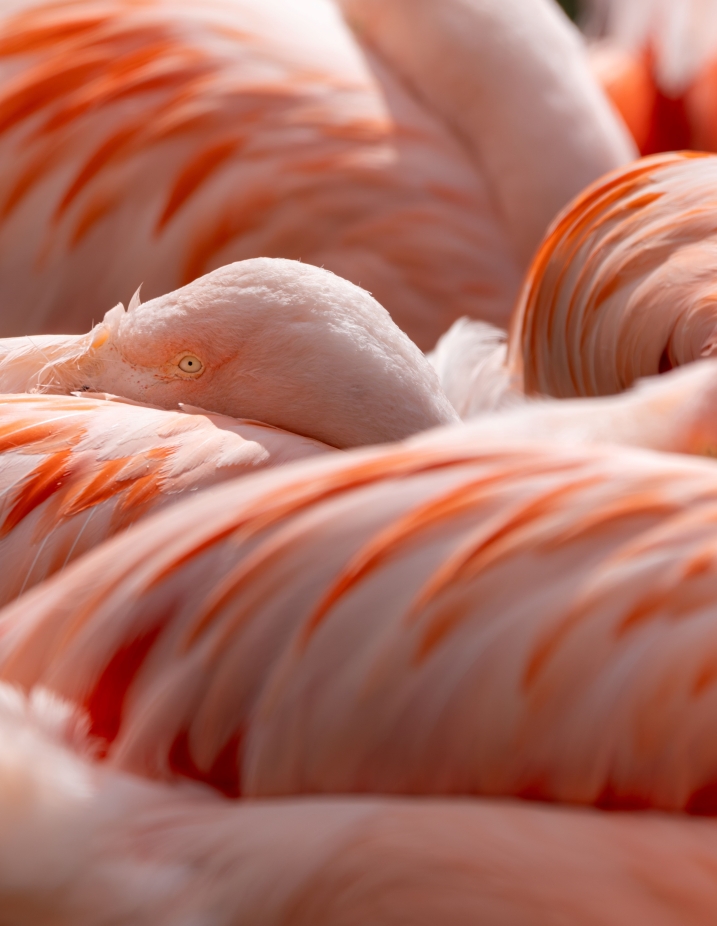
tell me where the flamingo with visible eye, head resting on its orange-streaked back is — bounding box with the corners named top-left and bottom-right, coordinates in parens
top-left (0, 259), bottom-right (470, 605)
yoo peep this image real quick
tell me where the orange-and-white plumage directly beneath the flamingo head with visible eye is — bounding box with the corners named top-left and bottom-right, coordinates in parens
top-left (0, 395), bottom-right (330, 604)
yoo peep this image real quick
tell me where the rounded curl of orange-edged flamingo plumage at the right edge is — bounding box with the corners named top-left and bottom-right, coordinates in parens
top-left (508, 153), bottom-right (717, 397)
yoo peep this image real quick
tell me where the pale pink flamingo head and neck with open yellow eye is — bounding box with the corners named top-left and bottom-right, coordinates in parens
top-left (0, 258), bottom-right (458, 448)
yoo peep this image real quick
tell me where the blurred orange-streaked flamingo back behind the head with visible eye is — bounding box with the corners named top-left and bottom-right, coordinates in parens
top-left (0, 0), bottom-right (520, 348)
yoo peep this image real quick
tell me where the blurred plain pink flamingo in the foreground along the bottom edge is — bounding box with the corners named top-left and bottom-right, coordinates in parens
top-left (7, 686), bottom-right (717, 926)
